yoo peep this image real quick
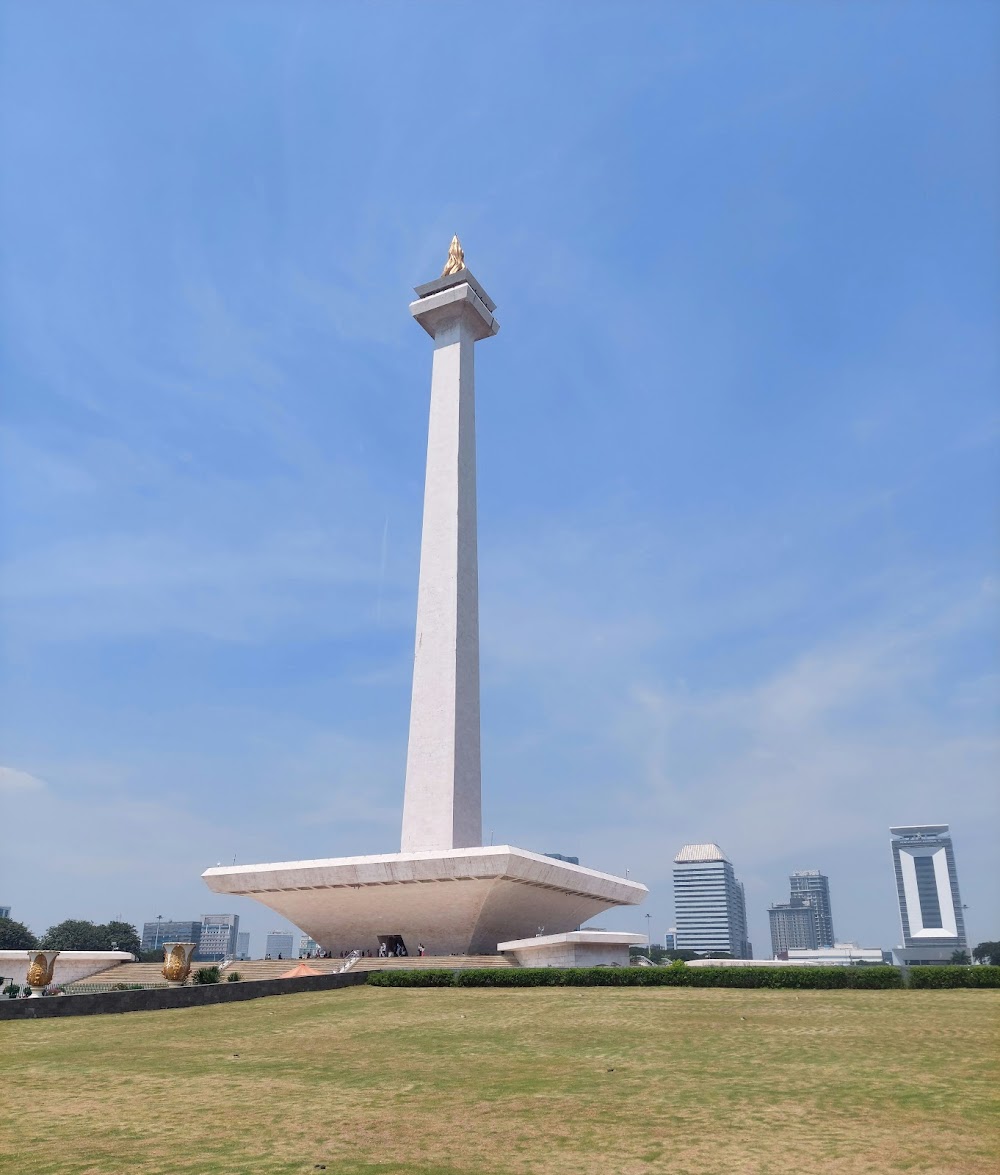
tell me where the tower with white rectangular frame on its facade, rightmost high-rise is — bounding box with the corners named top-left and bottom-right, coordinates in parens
top-left (890, 824), bottom-right (968, 965)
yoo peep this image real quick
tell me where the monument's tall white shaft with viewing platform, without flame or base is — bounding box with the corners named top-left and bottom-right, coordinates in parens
top-left (401, 269), bottom-right (499, 853)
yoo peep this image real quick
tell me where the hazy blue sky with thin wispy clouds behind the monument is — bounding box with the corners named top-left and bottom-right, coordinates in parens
top-left (0, 2), bottom-right (1000, 954)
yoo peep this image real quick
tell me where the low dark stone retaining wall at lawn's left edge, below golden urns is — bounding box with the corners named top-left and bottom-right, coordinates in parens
top-left (0, 972), bottom-right (368, 1020)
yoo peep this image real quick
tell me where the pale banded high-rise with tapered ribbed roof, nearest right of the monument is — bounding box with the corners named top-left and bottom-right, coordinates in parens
top-left (673, 845), bottom-right (753, 959)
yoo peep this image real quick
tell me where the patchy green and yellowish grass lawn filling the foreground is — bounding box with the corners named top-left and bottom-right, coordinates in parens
top-left (0, 987), bottom-right (1000, 1175)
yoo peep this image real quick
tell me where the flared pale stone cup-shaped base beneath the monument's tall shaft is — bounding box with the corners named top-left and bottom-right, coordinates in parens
top-left (202, 845), bottom-right (647, 954)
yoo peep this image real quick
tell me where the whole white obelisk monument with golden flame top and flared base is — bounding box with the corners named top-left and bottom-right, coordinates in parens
top-left (203, 243), bottom-right (647, 954)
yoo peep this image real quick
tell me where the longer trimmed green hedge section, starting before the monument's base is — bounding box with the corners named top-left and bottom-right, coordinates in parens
top-left (368, 967), bottom-right (907, 989)
